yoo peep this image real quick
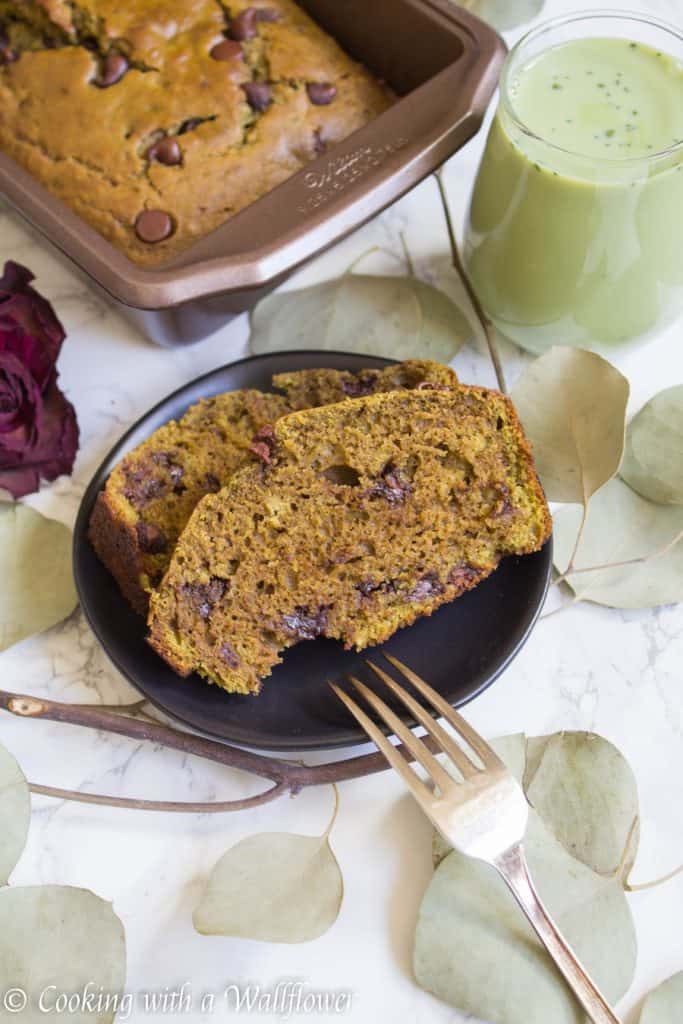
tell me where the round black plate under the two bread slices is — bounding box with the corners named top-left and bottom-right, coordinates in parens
top-left (74, 351), bottom-right (551, 750)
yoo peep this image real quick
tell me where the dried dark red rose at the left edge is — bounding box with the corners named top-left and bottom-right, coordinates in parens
top-left (0, 260), bottom-right (78, 498)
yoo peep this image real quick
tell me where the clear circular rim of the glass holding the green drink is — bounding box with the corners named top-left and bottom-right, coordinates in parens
top-left (500, 8), bottom-right (683, 167)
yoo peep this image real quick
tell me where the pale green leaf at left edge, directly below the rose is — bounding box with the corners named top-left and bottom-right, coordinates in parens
top-left (0, 504), bottom-right (78, 650)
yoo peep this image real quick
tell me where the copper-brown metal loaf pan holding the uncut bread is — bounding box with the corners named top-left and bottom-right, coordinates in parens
top-left (0, 0), bottom-right (505, 345)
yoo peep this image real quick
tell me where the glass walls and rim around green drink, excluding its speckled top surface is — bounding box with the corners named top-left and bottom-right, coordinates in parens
top-left (464, 11), bottom-right (683, 352)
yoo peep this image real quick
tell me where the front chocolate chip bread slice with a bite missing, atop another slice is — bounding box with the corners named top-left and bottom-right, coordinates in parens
top-left (148, 387), bottom-right (551, 693)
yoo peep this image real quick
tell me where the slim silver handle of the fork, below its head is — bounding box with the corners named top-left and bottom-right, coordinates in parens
top-left (495, 844), bottom-right (621, 1024)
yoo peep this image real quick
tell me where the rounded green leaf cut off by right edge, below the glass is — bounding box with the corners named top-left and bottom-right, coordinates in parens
top-left (621, 384), bottom-right (683, 505)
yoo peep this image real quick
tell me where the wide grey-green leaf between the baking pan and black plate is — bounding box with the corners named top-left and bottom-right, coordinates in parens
top-left (251, 273), bottom-right (472, 362)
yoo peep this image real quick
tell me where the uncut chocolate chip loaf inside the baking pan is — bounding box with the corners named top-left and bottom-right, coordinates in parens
top-left (0, 0), bottom-right (392, 265)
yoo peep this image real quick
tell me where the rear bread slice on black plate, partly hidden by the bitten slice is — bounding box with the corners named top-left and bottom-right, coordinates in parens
top-left (89, 360), bottom-right (457, 615)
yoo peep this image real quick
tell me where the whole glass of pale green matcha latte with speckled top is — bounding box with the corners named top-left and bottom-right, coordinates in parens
top-left (464, 11), bottom-right (683, 352)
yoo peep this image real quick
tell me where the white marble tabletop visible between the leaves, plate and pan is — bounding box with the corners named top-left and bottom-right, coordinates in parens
top-left (0, 0), bottom-right (683, 1024)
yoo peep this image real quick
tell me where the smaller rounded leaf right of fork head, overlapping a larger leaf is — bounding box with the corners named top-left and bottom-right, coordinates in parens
top-left (524, 732), bottom-right (640, 879)
